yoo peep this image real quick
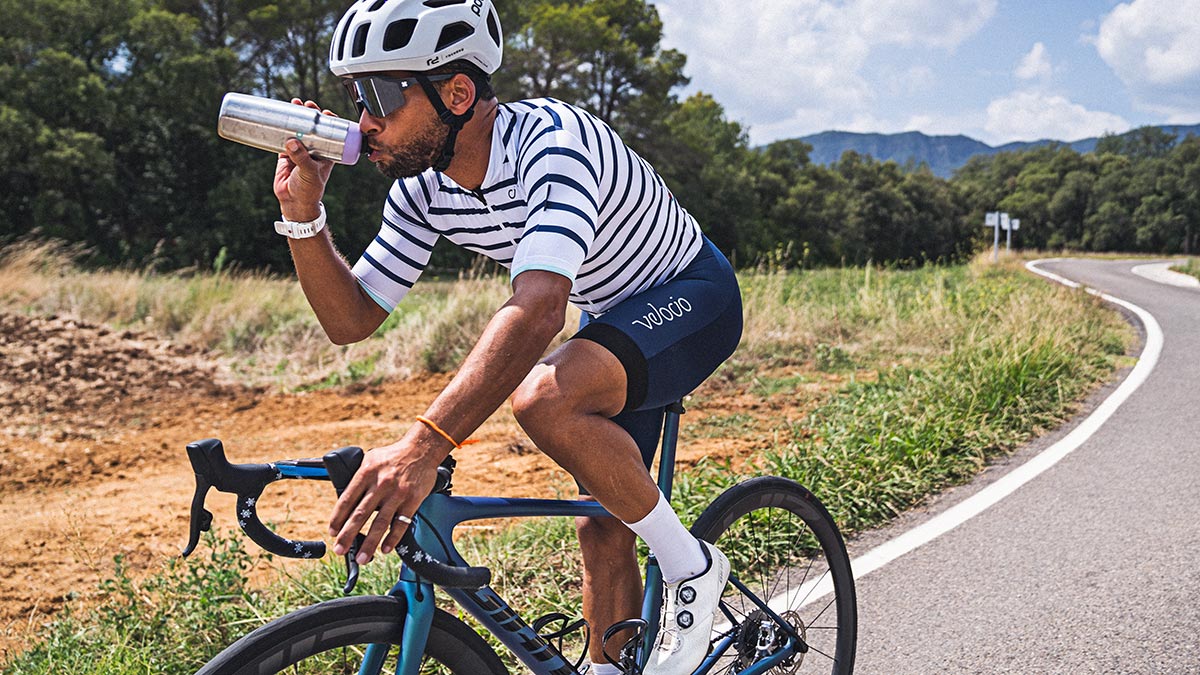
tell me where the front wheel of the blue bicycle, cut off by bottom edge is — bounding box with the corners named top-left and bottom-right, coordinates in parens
top-left (196, 596), bottom-right (508, 675)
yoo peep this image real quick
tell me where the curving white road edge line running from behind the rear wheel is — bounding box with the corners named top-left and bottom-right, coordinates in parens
top-left (770, 258), bottom-right (1163, 610)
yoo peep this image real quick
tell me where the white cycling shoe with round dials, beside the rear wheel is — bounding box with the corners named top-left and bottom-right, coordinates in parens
top-left (643, 542), bottom-right (730, 675)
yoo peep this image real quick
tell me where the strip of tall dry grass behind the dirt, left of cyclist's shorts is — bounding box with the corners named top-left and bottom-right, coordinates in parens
top-left (0, 241), bottom-right (578, 389)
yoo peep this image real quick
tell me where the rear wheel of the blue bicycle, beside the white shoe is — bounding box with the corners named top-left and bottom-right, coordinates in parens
top-left (691, 476), bottom-right (858, 675)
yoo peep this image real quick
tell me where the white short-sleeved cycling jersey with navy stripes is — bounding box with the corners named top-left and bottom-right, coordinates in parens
top-left (354, 98), bottom-right (701, 315)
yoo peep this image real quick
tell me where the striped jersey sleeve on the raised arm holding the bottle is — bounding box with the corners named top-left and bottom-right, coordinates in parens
top-left (353, 177), bottom-right (438, 312)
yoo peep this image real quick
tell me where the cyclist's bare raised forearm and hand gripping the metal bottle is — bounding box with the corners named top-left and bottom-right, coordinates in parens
top-left (274, 98), bottom-right (388, 345)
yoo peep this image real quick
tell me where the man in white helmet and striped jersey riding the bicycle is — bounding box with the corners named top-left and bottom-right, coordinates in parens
top-left (274, 0), bottom-right (742, 675)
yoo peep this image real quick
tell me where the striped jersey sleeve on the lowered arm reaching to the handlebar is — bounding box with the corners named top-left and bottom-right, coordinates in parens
top-left (512, 113), bottom-right (600, 281)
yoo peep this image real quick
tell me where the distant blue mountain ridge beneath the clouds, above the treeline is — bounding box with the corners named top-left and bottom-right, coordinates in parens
top-left (800, 124), bottom-right (1200, 178)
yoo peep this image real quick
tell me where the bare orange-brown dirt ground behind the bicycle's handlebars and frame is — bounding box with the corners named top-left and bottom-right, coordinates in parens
top-left (0, 313), bottom-right (817, 657)
